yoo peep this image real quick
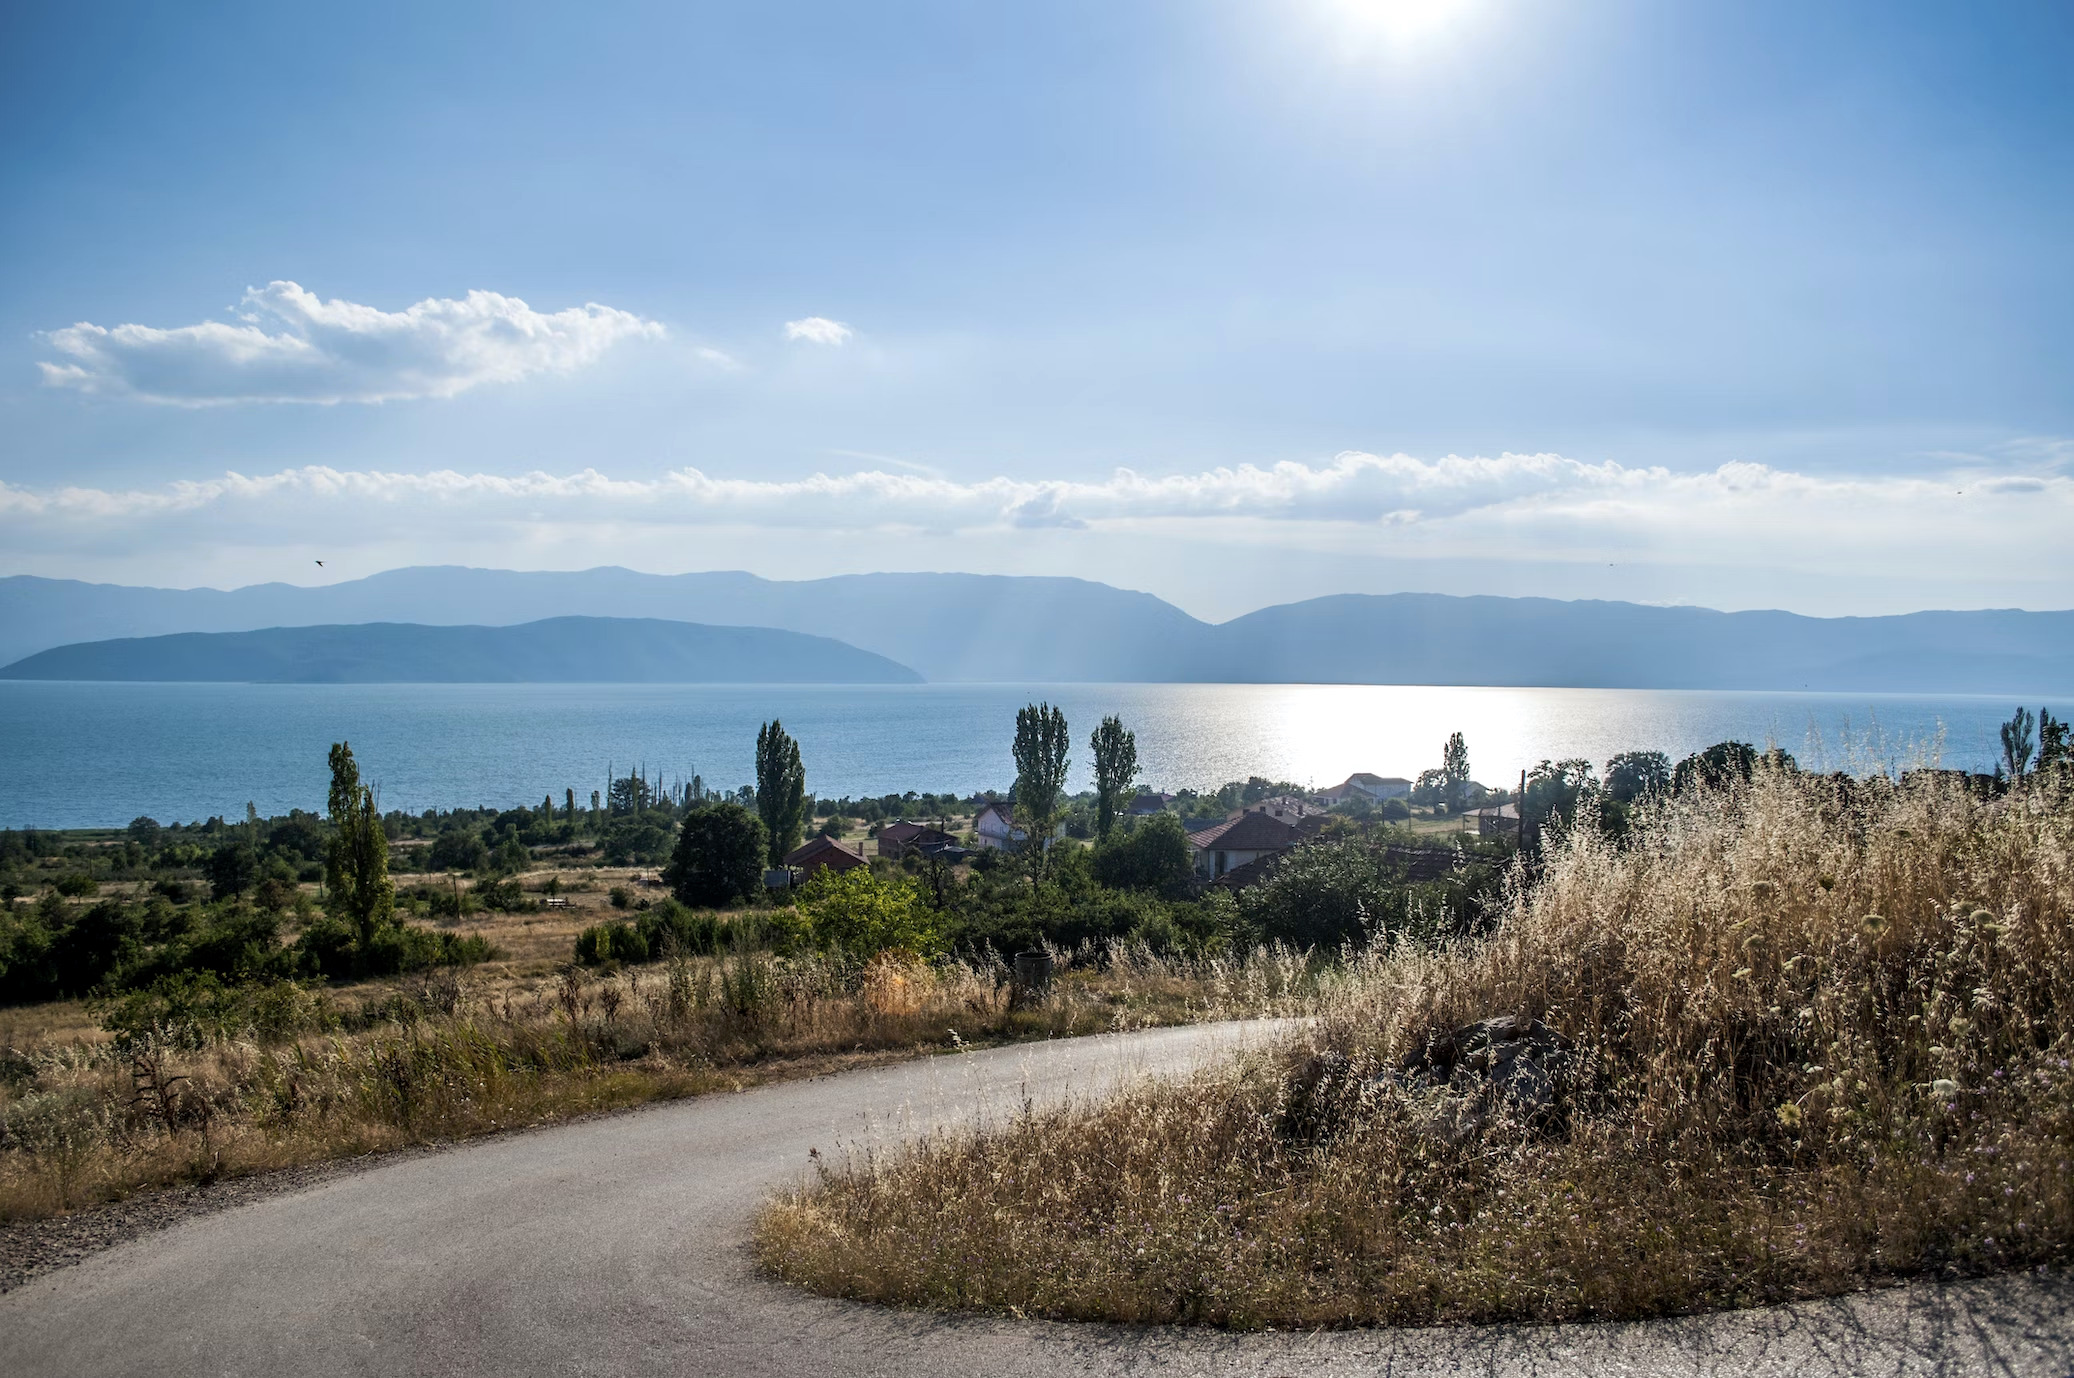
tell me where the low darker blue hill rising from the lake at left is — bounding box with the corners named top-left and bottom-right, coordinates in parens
top-left (0, 616), bottom-right (921, 685)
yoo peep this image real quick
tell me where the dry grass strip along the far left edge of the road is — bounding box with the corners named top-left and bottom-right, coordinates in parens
top-left (0, 942), bottom-right (1311, 1222)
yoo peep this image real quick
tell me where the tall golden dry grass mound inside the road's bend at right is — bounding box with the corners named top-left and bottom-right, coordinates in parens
top-left (759, 774), bottom-right (2074, 1326)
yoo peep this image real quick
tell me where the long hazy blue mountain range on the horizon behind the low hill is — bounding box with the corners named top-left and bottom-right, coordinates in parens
top-left (0, 567), bottom-right (2074, 693)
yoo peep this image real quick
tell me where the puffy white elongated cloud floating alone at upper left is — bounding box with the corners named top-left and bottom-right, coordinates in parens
top-left (39, 282), bottom-right (664, 407)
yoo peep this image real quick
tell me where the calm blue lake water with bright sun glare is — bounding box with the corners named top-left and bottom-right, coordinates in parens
top-left (0, 681), bottom-right (2059, 828)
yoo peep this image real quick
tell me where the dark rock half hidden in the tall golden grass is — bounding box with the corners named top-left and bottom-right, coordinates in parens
top-left (1398, 1015), bottom-right (1576, 1139)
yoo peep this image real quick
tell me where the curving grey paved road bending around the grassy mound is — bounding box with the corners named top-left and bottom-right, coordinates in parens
top-left (0, 1025), bottom-right (2074, 1378)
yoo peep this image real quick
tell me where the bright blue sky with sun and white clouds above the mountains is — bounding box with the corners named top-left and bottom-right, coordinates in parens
top-left (0, 0), bottom-right (2074, 618)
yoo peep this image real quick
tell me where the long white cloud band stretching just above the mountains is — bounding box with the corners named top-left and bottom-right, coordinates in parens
top-left (0, 452), bottom-right (2074, 602)
